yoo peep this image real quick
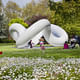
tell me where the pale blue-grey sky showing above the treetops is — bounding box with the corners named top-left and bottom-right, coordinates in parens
top-left (2, 0), bottom-right (62, 8)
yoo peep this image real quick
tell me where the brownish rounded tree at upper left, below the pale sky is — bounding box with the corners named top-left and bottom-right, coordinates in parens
top-left (5, 1), bottom-right (22, 20)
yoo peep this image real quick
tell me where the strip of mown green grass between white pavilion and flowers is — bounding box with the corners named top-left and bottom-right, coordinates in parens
top-left (0, 43), bottom-right (80, 59)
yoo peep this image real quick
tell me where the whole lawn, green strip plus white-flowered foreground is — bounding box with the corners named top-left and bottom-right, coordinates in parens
top-left (0, 43), bottom-right (80, 80)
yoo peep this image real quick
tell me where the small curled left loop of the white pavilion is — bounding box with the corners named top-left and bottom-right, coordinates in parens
top-left (9, 23), bottom-right (26, 41)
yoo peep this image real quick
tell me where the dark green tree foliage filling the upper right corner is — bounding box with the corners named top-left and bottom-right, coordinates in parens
top-left (49, 0), bottom-right (80, 35)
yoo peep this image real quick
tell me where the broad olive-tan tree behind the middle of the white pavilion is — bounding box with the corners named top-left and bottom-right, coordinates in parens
top-left (23, 0), bottom-right (54, 23)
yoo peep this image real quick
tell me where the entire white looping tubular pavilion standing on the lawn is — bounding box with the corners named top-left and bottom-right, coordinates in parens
top-left (9, 19), bottom-right (68, 48)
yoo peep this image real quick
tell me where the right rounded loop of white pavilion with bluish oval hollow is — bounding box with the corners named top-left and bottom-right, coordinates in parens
top-left (44, 24), bottom-right (68, 46)
